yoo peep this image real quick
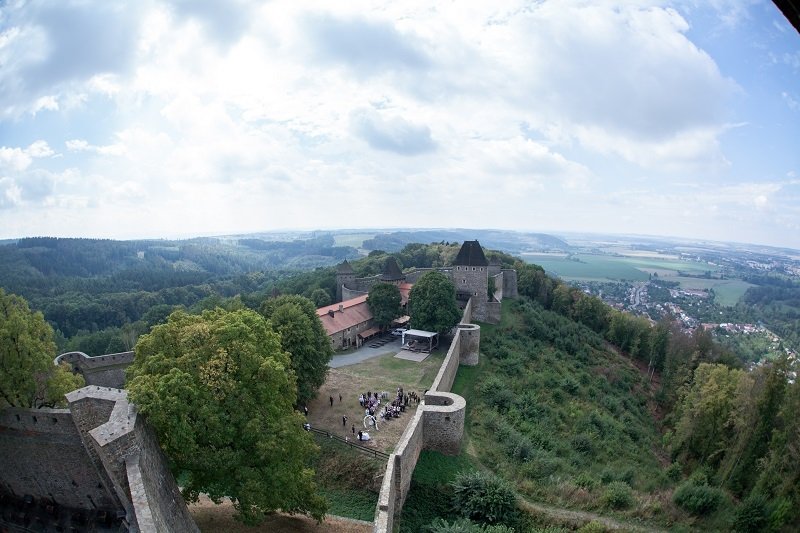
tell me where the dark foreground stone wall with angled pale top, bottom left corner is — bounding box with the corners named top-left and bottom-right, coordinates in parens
top-left (0, 385), bottom-right (199, 532)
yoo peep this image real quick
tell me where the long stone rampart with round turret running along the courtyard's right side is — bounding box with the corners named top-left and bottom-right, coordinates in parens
top-left (373, 299), bottom-right (480, 533)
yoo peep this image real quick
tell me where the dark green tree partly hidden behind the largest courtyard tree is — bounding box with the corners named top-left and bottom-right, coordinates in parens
top-left (261, 294), bottom-right (333, 405)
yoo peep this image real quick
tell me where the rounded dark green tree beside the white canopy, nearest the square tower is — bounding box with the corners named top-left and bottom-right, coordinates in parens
top-left (410, 271), bottom-right (461, 333)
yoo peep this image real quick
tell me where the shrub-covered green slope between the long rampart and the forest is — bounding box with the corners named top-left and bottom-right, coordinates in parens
top-left (472, 301), bottom-right (670, 517)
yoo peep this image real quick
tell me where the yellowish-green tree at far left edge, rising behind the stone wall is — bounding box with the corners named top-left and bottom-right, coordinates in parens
top-left (0, 289), bottom-right (84, 408)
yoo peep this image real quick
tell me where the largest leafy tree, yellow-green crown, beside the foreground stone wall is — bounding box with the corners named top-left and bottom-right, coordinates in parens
top-left (128, 309), bottom-right (326, 524)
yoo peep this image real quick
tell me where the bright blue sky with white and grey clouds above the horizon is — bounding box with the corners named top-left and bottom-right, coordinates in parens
top-left (0, 0), bottom-right (800, 248)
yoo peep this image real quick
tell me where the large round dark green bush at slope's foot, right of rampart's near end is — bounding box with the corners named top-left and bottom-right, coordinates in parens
top-left (452, 471), bottom-right (517, 524)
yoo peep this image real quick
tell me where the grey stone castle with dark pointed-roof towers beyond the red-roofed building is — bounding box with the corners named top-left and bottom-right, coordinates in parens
top-left (336, 241), bottom-right (517, 324)
